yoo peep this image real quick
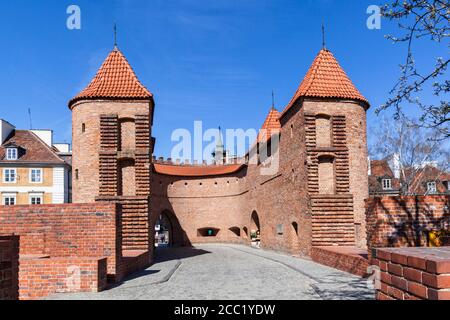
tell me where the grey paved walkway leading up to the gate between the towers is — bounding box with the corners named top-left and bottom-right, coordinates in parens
top-left (47, 245), bottom-right (374, 300)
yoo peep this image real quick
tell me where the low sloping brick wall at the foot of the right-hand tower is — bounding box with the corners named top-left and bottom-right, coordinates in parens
top-left (311, 247), bottom-right (369, 277)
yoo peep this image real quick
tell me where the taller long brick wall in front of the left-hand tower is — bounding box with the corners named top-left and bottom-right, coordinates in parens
top-left (0, 203), bottom-right (122, 275)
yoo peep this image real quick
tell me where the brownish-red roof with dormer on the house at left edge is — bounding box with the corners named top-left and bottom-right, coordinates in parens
top-left (0, 130), bottom-right (64, 164)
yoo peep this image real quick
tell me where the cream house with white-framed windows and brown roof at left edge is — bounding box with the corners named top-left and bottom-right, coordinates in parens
top-left (0, 119), bottom-right (71, 205)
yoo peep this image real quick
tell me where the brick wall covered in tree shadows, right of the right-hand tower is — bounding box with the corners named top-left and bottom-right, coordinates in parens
top-left (366, 196), bottom-right (450, 248)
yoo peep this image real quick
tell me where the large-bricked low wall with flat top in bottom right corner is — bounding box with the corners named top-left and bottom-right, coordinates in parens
top-left (372, 247), bottom-right (450, 300)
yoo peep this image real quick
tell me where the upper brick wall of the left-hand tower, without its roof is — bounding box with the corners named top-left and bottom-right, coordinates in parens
top-left (72, 100), bottom-right (153, 203)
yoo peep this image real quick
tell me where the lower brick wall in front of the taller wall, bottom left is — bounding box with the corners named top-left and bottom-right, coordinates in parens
top-left (19, 257), bottom-right (107, 300)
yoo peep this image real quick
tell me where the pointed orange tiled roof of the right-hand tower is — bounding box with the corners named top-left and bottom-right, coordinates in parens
top-left (283, 49), bottom-right (369, 114)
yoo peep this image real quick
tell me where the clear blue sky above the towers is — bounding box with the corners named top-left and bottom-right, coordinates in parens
top-left (0, 0), bottom-right (445, 156)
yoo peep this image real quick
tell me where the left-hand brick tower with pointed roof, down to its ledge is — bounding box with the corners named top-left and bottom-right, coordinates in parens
top-left (69, 48), bottom-right (154, 203)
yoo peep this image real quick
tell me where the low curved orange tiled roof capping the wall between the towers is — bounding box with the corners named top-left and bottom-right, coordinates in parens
top-left (154, 163), bottom-right (243, 177)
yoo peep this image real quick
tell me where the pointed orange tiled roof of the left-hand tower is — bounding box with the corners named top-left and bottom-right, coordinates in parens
top-left (69, 48), bottom-right (153, 107)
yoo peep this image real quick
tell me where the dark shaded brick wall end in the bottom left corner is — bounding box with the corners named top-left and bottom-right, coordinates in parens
top-left (0, 236), bottom-right (19, 300)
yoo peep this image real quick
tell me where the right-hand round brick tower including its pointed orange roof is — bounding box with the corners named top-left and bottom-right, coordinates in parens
top-left (281, 49), bottom-right (370, 247)
